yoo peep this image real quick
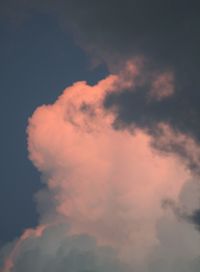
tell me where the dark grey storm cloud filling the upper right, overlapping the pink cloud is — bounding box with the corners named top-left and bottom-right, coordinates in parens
top-left (2, 0), bottom-right (200, 140)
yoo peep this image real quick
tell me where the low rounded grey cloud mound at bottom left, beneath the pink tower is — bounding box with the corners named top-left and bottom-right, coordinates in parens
top-left (8, 224), bottom-right (129, 272)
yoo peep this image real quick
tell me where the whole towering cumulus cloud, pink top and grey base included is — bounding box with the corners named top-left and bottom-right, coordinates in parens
top-left (1, 65), bottom-right (200, 272)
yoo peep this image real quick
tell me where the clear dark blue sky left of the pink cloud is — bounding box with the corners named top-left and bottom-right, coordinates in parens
top-left (0, 14), bottom-right (106, 243)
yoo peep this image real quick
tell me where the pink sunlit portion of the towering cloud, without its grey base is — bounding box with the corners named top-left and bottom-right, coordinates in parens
top-left (2, 63), bottom-right (200, 272)
